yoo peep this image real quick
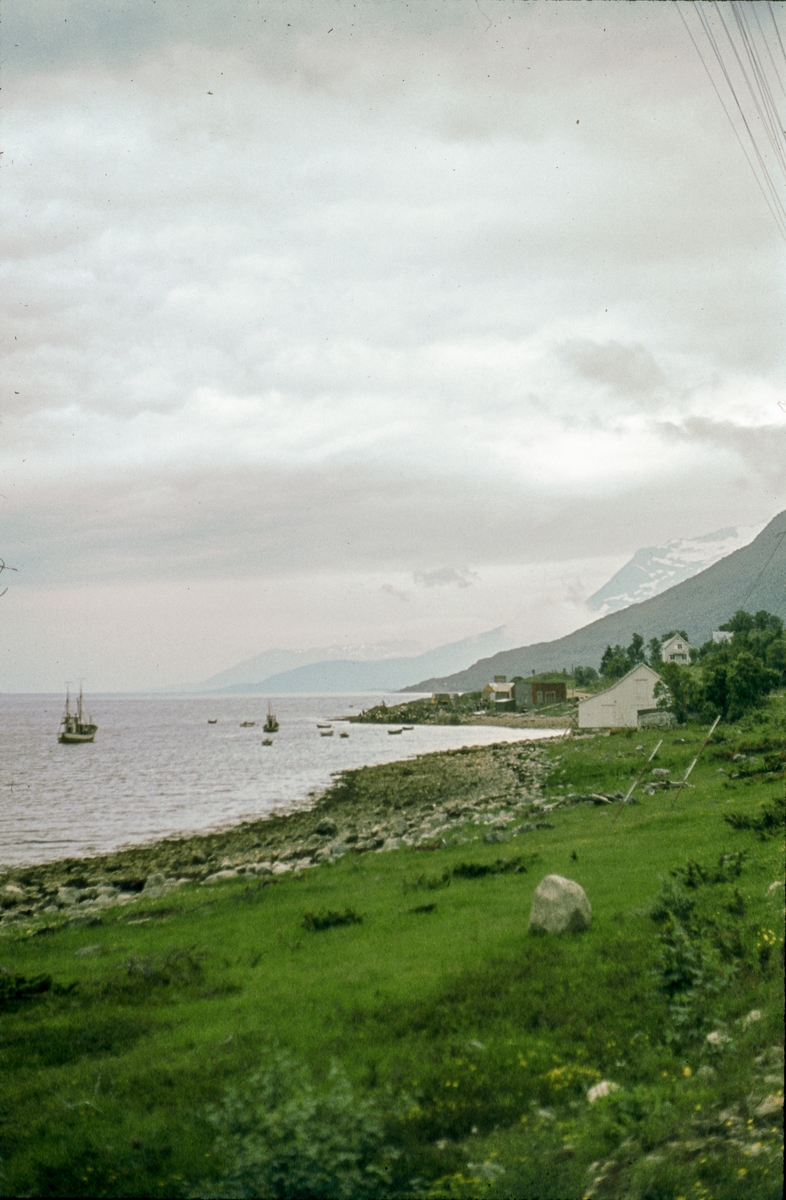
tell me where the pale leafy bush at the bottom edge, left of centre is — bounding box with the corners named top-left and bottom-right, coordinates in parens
top-left (202, 1049), bottom-right (395, 1200)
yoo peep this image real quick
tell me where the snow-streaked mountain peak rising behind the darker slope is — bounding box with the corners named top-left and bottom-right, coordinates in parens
top-left (587, 524), bottom-right (763, 617)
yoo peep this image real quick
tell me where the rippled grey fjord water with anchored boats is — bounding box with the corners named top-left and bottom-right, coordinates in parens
top-left (0, 695), bottom-right (562, 865)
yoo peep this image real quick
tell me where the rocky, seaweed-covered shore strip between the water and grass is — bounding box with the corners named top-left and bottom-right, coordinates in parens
top-left (0, 739), bottom-right (583, 935)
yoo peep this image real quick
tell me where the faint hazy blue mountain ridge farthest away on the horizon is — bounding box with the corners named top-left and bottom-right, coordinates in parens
top-left (205, 625), bottom-right (513, 695)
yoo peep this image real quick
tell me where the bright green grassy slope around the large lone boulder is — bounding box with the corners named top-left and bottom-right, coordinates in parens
top-left (0, 697), bottom-right (786, 1198)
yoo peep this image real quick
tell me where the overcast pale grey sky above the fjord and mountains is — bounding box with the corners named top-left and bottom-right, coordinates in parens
top-left (0, 0), bottom-right (786, 692)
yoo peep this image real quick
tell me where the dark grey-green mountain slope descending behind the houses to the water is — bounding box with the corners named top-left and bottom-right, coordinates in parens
top-left (403, 511), bottom-right (786, 691)
